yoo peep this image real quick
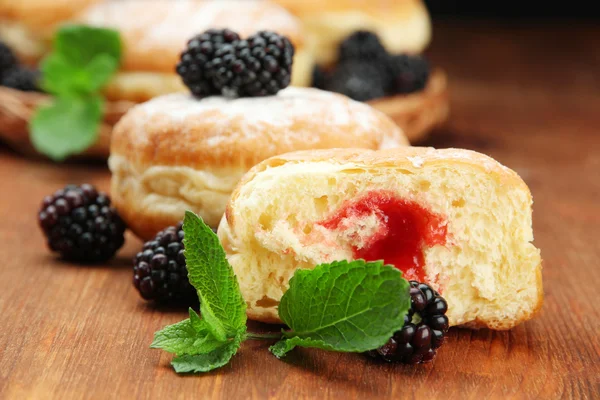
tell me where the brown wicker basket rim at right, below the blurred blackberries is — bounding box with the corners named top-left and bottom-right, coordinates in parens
top-left (369, 69), bottom-right (450, 143)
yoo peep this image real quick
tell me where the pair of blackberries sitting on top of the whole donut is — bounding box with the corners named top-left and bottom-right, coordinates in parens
top-left (177, 29), bottom-right (294, 97)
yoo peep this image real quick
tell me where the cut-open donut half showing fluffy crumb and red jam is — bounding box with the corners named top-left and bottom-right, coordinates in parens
top-left (218, 147), bottom-right (543, 330)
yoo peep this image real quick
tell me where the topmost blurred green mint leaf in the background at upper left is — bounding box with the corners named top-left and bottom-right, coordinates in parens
top-left (53, 25), bottom-right (122, 68)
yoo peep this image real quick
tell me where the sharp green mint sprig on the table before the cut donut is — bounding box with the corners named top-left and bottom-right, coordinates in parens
top-left (151, 211), bottom-right (410, 373)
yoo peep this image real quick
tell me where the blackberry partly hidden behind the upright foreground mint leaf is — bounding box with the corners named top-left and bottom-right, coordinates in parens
top-left (133, 222), bottom-right (198, 305)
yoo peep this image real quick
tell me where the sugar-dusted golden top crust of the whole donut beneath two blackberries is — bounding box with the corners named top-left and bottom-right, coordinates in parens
top-left (111, 88), bottom-right (407, 169)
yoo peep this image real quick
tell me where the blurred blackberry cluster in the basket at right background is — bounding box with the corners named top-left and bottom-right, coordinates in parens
top-left (313, 31), bottom-right (429, 101)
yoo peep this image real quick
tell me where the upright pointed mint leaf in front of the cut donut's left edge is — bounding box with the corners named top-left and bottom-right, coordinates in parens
top-left (183, 211), bottom-right (246, 340)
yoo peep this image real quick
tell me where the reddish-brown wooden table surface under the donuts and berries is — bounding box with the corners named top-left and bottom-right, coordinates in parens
top-left (0, 21), bottom-right (600, 399)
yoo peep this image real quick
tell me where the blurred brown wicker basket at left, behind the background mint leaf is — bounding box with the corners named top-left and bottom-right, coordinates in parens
top-left (0, 87), bottom-right (134, 159)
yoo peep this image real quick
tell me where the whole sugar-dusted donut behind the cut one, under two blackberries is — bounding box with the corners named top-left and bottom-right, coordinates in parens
top-left (109, 87), bottom-right (408, 238)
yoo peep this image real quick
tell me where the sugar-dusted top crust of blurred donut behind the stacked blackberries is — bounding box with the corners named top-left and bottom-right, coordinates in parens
top-left (76, 0), bottom-right (304, 72)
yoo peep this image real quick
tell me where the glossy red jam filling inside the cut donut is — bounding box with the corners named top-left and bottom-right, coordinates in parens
top-left (321, 191), bottom-right (447, 282)
